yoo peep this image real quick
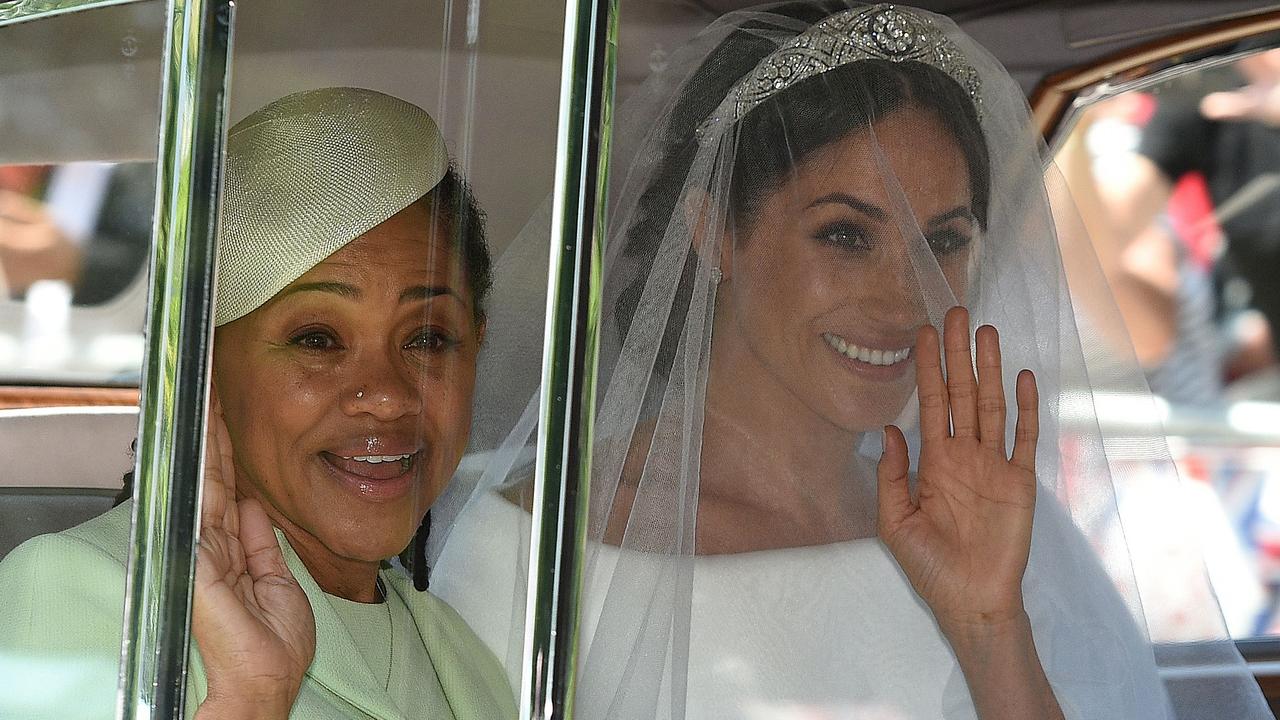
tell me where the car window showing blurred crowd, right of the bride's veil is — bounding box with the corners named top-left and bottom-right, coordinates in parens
top-left (1056, 41), bottom-right (1280, 639)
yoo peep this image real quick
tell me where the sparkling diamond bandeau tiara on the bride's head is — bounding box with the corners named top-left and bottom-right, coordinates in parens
top-left (698, 5), bottom-right (982, 136)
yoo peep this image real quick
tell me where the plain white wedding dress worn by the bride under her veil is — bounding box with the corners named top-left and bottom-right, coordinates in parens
top-left (431, 484), bottom-right (1164, 720)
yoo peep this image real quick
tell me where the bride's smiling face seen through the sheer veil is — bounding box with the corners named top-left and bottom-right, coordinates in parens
top-left (718, 108), bottom-right (979, 432)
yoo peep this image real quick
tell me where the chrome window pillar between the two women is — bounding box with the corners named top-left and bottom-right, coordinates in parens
top-left (518, 0), bottom-right (617, 720)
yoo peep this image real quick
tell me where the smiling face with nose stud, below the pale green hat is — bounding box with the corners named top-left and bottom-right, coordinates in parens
top-left (214, 202), bottom-right (483, 561)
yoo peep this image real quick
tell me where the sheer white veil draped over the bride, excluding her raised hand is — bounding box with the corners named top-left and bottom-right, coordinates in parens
top-left (431, 1), bottom-right (1271, 720)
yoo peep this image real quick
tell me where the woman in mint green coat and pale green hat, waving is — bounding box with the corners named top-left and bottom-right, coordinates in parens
top-left (0, 88), bottom-right (515, 720)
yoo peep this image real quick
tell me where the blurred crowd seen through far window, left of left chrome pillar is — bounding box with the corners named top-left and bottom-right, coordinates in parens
top-left (0, 163), bottom-right (155, 384)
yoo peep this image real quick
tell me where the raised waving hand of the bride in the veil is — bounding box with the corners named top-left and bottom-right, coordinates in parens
top-left (878, 302), bottom-right (1039, 632)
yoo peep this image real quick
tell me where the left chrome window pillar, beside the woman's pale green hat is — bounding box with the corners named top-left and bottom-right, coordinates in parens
top-left (118, 0), bottom-right (234, 720)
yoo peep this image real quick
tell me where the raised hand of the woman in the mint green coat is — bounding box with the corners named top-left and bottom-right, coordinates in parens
top-left (192, 391), bottom-right (316, 720)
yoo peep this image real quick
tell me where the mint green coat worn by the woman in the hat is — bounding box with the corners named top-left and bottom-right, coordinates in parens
top-left (0, 503), bottom-right (516, 720)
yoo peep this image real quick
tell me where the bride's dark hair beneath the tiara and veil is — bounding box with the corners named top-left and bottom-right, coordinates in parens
top-left (605, 0), bottom-right (991, 375)
